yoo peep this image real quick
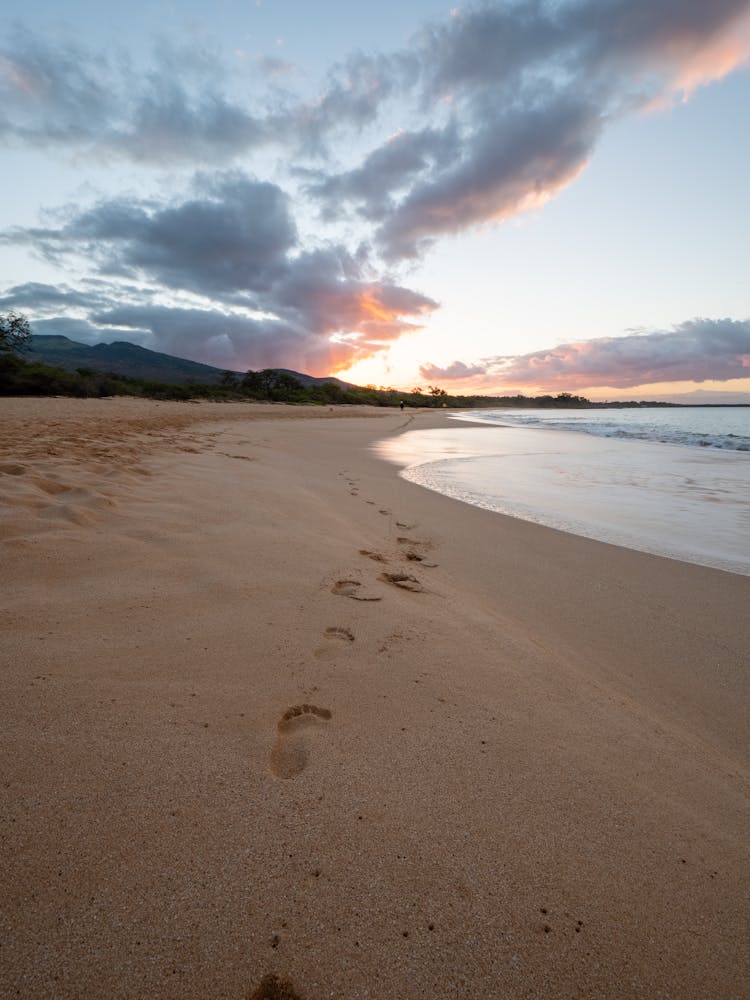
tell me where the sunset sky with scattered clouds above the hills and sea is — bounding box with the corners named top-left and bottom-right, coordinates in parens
top-left (0, 0), bottom-right (750, 403)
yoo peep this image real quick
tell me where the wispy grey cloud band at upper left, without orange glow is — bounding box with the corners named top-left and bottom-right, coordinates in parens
top-left (0, 26), bottom-right (417, 165)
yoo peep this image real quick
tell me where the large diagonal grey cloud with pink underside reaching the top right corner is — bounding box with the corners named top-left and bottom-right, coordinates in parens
top-left (309, 0), bottom-right (750, 261)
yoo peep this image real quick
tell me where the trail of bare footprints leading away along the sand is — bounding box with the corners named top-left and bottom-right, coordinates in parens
top-left (270, 470), bottom-right (437, 780)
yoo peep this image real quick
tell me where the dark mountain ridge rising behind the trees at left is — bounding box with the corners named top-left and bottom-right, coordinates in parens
top-left (26, 334), bottom-right (351, 389)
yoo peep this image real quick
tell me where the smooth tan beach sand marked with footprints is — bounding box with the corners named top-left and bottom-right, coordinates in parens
top-left (0, 399), bottom-right (750, 1000)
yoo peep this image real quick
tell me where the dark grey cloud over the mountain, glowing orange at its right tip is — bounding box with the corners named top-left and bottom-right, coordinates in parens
top-left (0, 171), bottom-right (437, 372)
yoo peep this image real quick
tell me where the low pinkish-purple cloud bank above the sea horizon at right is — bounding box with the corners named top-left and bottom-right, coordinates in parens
top-left (485, 319), bottom-right (750, 392)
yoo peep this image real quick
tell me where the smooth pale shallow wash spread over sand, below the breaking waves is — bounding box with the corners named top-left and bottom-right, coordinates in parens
top-left (382, 420), bottom-right (750, 576)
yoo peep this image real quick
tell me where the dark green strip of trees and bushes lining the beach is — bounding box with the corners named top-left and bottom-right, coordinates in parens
top-left (0, 313), bottom-right (680, 409)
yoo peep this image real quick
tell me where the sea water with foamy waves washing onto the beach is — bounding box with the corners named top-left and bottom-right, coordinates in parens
top-left (377, 407), bottom-right (750, 575)
